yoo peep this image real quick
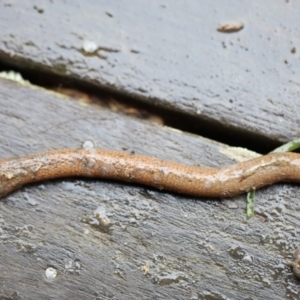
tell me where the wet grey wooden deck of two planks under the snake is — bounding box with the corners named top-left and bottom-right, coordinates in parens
top-left (0, 0), bottom-right (300, 300)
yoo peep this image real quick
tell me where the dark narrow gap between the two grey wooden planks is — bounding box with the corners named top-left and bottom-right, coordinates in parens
top-left (0, 61), bottom-right (280, 154)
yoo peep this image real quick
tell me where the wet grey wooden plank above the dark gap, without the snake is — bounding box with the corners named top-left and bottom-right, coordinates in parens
top-left (0, 0), bottom-right (300, 148)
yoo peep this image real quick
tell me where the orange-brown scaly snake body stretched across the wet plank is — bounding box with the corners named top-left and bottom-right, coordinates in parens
top-left (0, 149), bottom-right (300, 198)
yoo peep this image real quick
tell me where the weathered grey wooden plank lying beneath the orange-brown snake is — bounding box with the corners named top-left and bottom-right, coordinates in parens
top-left (0, 80), bottom-right (300, 300)
